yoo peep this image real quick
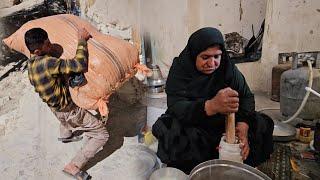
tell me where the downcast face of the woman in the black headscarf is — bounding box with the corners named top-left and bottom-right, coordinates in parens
top-left (196, 46), bottom-right (222, 74)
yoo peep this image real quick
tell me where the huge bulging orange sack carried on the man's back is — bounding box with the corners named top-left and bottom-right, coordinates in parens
top-left (3, 14), bottom-right (143, 116)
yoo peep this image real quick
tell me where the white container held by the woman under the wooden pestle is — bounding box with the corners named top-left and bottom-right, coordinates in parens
top-left (219, 136), bottom-right (243, 163)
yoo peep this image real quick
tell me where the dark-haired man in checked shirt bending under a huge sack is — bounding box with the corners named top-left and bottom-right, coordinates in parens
top-left (24, 28), bottom-right (109, 179)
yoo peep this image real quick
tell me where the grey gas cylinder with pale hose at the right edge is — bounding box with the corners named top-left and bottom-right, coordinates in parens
top-left (280, 53), bottom-right (320, 120)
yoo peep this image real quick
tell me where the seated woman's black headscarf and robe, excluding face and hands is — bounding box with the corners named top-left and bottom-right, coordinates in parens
top-left (152, 27), bottom-right (272, 173)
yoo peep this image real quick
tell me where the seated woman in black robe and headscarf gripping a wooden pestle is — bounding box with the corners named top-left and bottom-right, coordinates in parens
top-left (152, 27), bottom-right (273, 173)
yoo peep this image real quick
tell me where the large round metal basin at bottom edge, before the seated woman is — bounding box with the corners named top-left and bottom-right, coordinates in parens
top-left (189, 159), bottom-right (271, 180)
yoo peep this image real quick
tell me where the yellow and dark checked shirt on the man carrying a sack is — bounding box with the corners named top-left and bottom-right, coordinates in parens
top-left (28, 40), bottom-right (88, 110)
